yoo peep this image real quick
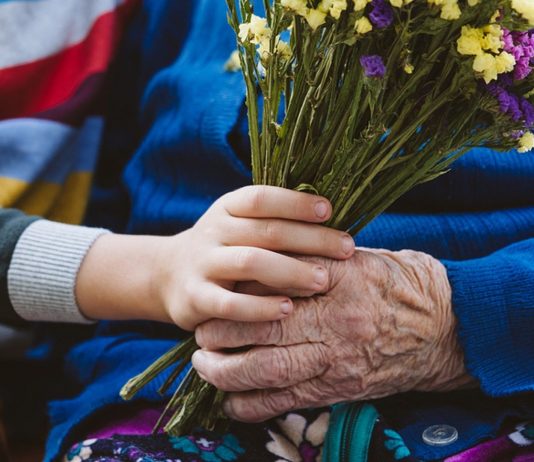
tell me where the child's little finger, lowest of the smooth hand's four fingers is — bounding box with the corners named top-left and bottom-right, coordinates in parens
top-left (192, 284), bottom-right (293, 322)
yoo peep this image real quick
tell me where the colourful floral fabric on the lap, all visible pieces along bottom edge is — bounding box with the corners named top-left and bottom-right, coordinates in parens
top-left (64, 409), bottom-right (534, 462)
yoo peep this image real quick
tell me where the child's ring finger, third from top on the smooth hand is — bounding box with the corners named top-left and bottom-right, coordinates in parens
top-left (206, 247), bottom-right (328, 292)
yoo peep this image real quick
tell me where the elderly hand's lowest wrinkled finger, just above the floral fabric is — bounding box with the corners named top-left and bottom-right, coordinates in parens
top-left (224, 377), bottom-right (339, 422)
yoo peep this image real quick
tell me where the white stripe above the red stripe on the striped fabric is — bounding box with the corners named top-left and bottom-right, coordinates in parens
top-left (0, 0), bottom-right (126, 70)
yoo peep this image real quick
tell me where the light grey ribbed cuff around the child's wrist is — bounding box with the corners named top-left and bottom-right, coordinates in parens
top-left (7, 220), bottom-right (109, 324)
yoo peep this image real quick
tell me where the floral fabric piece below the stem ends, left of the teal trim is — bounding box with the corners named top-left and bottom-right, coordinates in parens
top-left (64, 409), bottom-right (330, 462)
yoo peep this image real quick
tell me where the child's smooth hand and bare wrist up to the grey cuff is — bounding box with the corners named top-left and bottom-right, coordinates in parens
top-left (76, 186), bottom-right (354, 330)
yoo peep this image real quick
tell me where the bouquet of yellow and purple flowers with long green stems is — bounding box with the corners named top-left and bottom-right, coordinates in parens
top-left (122, 0), bottom-right (534, 434)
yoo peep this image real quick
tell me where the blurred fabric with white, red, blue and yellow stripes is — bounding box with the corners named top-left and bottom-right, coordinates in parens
top-left (0, 0), bottom-right (138, 224)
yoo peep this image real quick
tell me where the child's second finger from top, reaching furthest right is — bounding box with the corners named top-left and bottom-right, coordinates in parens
top-left (222, 218), bottom-right (355, 259)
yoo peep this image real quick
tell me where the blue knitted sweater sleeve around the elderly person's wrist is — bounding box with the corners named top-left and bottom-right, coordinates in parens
top-left (443, 239), bottom-right (534, 396)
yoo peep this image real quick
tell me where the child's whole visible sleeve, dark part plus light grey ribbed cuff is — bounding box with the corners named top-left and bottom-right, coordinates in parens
top-left (0, 209), bottom-right (108, 325)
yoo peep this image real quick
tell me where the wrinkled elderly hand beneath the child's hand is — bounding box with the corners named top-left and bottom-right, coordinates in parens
top-left (193, 249), bottom-right (473, 422)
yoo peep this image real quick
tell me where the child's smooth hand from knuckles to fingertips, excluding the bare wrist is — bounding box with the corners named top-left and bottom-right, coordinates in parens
top-left (155, 186), bottom-right (354, 329)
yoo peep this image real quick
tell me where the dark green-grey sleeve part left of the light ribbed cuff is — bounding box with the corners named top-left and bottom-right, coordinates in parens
top-left (0, 209), bottom-right (37, 326)
